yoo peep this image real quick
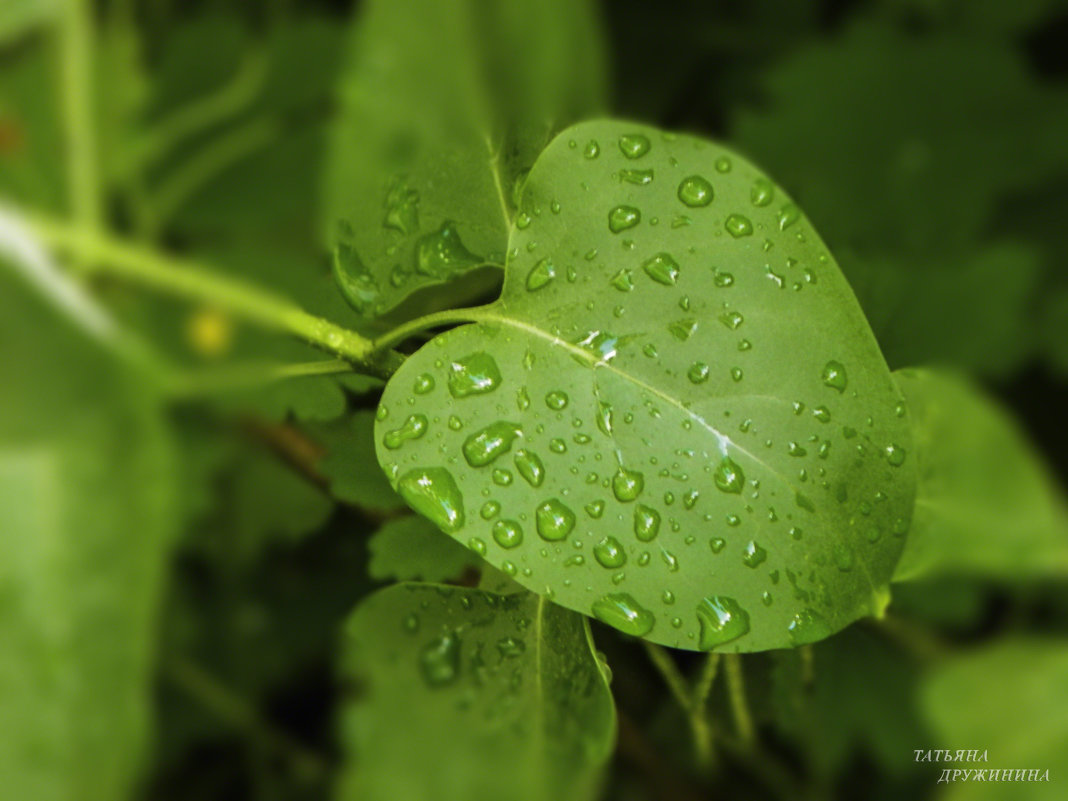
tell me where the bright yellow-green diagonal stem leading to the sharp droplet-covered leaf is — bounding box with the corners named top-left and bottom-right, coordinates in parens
top-left (32, 211), bottom-right (404, 378)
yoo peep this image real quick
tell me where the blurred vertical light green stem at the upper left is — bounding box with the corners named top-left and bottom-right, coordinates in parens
top-left (60, 0), bottom-right (103, 227)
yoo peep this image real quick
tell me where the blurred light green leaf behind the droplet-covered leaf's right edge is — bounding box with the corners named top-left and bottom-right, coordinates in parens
top-left (894, 370), bottom-right (1068, 581)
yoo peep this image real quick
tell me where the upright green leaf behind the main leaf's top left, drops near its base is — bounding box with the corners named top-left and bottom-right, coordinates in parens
top-left (326, 0), bottom-right (604, 315)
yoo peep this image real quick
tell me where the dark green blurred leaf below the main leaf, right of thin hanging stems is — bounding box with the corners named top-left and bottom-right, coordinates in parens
top-left (772, 626), bottom-right (928, 776)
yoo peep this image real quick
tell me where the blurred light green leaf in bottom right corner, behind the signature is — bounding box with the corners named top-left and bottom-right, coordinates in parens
top-left (917, 639), bottom-right (1068, 801)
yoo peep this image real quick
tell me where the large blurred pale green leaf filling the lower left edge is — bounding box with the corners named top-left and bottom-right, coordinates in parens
top-left (0, 264), bottom-right (177, 801)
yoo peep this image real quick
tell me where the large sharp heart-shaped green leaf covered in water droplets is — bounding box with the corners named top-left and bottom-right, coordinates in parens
top-left (376, 122), bottom-right (915, 650)
